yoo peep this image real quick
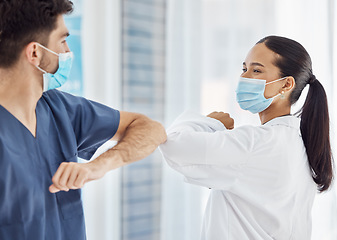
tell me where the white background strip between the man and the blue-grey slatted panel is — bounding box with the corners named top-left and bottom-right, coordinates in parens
top-left (80, 0), bottom-right (121, 240)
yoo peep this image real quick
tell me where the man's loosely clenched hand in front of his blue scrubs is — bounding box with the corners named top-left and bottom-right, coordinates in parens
top-left (49, 161), bottom-right (106, 193)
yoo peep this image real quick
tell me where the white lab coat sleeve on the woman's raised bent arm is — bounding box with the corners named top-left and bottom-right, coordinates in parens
top-left (160, 112), bottom-right (254, 189)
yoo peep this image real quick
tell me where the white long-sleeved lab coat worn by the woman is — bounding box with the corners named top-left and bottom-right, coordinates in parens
top-left (160, 112), bottom-right (317, 240)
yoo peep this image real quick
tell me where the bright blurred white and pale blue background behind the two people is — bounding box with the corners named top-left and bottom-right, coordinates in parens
top-left (63, 0), bottom-right (337, 240)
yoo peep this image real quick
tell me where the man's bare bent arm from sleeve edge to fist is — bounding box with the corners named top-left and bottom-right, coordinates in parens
top-left (49, 114), bottom-right (166, 193)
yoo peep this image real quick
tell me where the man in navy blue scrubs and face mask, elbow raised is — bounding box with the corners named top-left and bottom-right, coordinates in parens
top-left (0, 0), bottom-right (166, 240)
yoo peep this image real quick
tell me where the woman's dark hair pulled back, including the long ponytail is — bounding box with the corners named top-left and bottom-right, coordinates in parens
top-left (257, 36), bottom-right (333, 192)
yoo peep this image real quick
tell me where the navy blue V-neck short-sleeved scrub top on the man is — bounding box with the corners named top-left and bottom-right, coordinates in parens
top-left (0, 90), bottom-right (120, 240)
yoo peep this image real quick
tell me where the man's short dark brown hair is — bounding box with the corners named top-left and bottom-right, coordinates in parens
top-left (0, 0), bottom-right (73, 67)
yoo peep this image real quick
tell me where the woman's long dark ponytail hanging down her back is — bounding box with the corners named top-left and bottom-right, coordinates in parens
top-left (299, 78), bottom-right (333, 192)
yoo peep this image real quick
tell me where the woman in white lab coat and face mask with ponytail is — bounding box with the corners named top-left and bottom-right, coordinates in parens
top-left (160, 36), bottom-right (333, 240)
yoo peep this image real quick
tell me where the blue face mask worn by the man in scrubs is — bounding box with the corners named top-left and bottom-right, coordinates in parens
top-left (36, 44), bottom-right (74, 92)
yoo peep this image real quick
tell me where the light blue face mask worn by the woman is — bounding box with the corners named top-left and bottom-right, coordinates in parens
top-left (236, 77), bottom-right (287, 113)
